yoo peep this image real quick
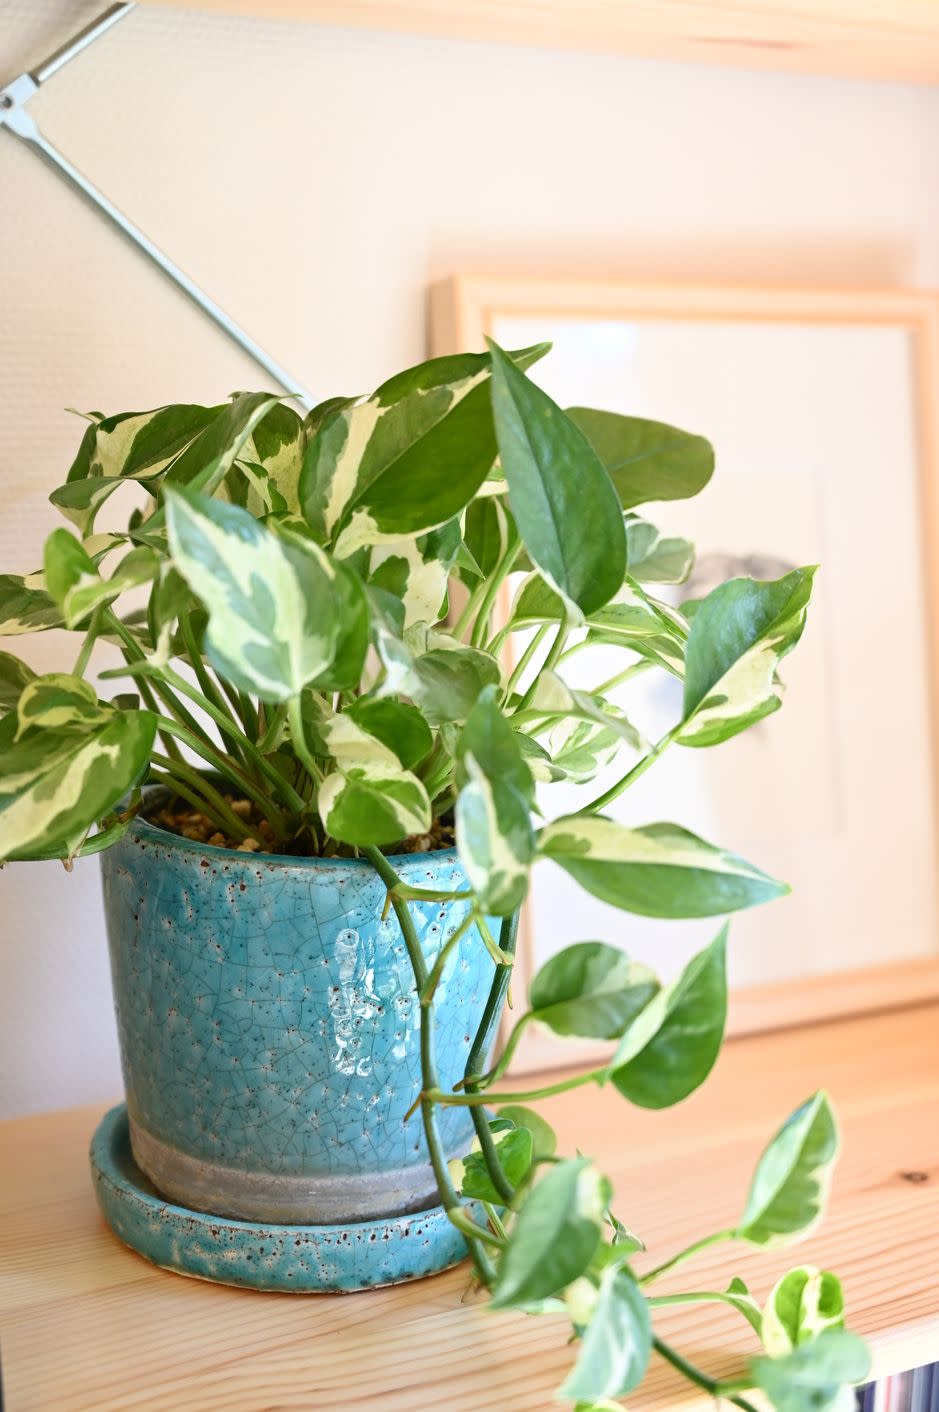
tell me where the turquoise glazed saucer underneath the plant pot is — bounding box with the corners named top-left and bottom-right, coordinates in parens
top-left (90, 1103), bottom-right (466, 1293)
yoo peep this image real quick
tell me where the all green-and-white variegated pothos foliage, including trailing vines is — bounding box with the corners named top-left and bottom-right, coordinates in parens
top-left (0, 345), bottom-right (864, 1412)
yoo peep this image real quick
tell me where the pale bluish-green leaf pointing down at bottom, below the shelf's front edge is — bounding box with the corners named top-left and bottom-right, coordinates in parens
top-left (559, 1265), bottom-right (652, 1399)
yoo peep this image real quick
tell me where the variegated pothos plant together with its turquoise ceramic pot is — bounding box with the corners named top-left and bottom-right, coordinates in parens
top-left (0, 345), bottom-right (867, 1412)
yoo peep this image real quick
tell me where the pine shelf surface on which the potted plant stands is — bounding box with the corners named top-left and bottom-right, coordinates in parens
top-left (0, 1004), bottom-right (939, 1412)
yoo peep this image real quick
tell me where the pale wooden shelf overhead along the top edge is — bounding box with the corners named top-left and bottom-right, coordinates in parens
top-left (141, 0), bottom-right (939, 83)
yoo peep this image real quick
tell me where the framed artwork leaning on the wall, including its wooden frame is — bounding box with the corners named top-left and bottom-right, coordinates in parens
top-left (432, 278), bottom-right (939, 1069)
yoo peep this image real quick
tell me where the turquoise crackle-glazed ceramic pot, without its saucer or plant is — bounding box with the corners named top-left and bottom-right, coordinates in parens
top-left (102, 820), bottom-right (493, 1224)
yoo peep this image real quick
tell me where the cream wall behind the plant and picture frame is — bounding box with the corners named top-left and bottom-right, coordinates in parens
top-left (0, 0), bottom-right (939, 1113)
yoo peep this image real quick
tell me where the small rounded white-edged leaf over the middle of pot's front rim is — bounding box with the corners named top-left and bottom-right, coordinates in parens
top-left (318, 768), bottom-right (431, 847)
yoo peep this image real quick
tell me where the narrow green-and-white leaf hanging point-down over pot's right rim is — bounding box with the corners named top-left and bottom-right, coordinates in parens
top-left (456, 686), bottom-right (535, 916)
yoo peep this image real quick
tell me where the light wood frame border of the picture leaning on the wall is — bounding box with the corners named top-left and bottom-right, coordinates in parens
top-left (429, 277), bottom-right (939, 1072)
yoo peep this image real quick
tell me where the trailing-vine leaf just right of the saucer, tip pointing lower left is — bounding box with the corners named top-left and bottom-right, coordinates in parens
top-left (491, 1158), bottom-right (610, 1309)
